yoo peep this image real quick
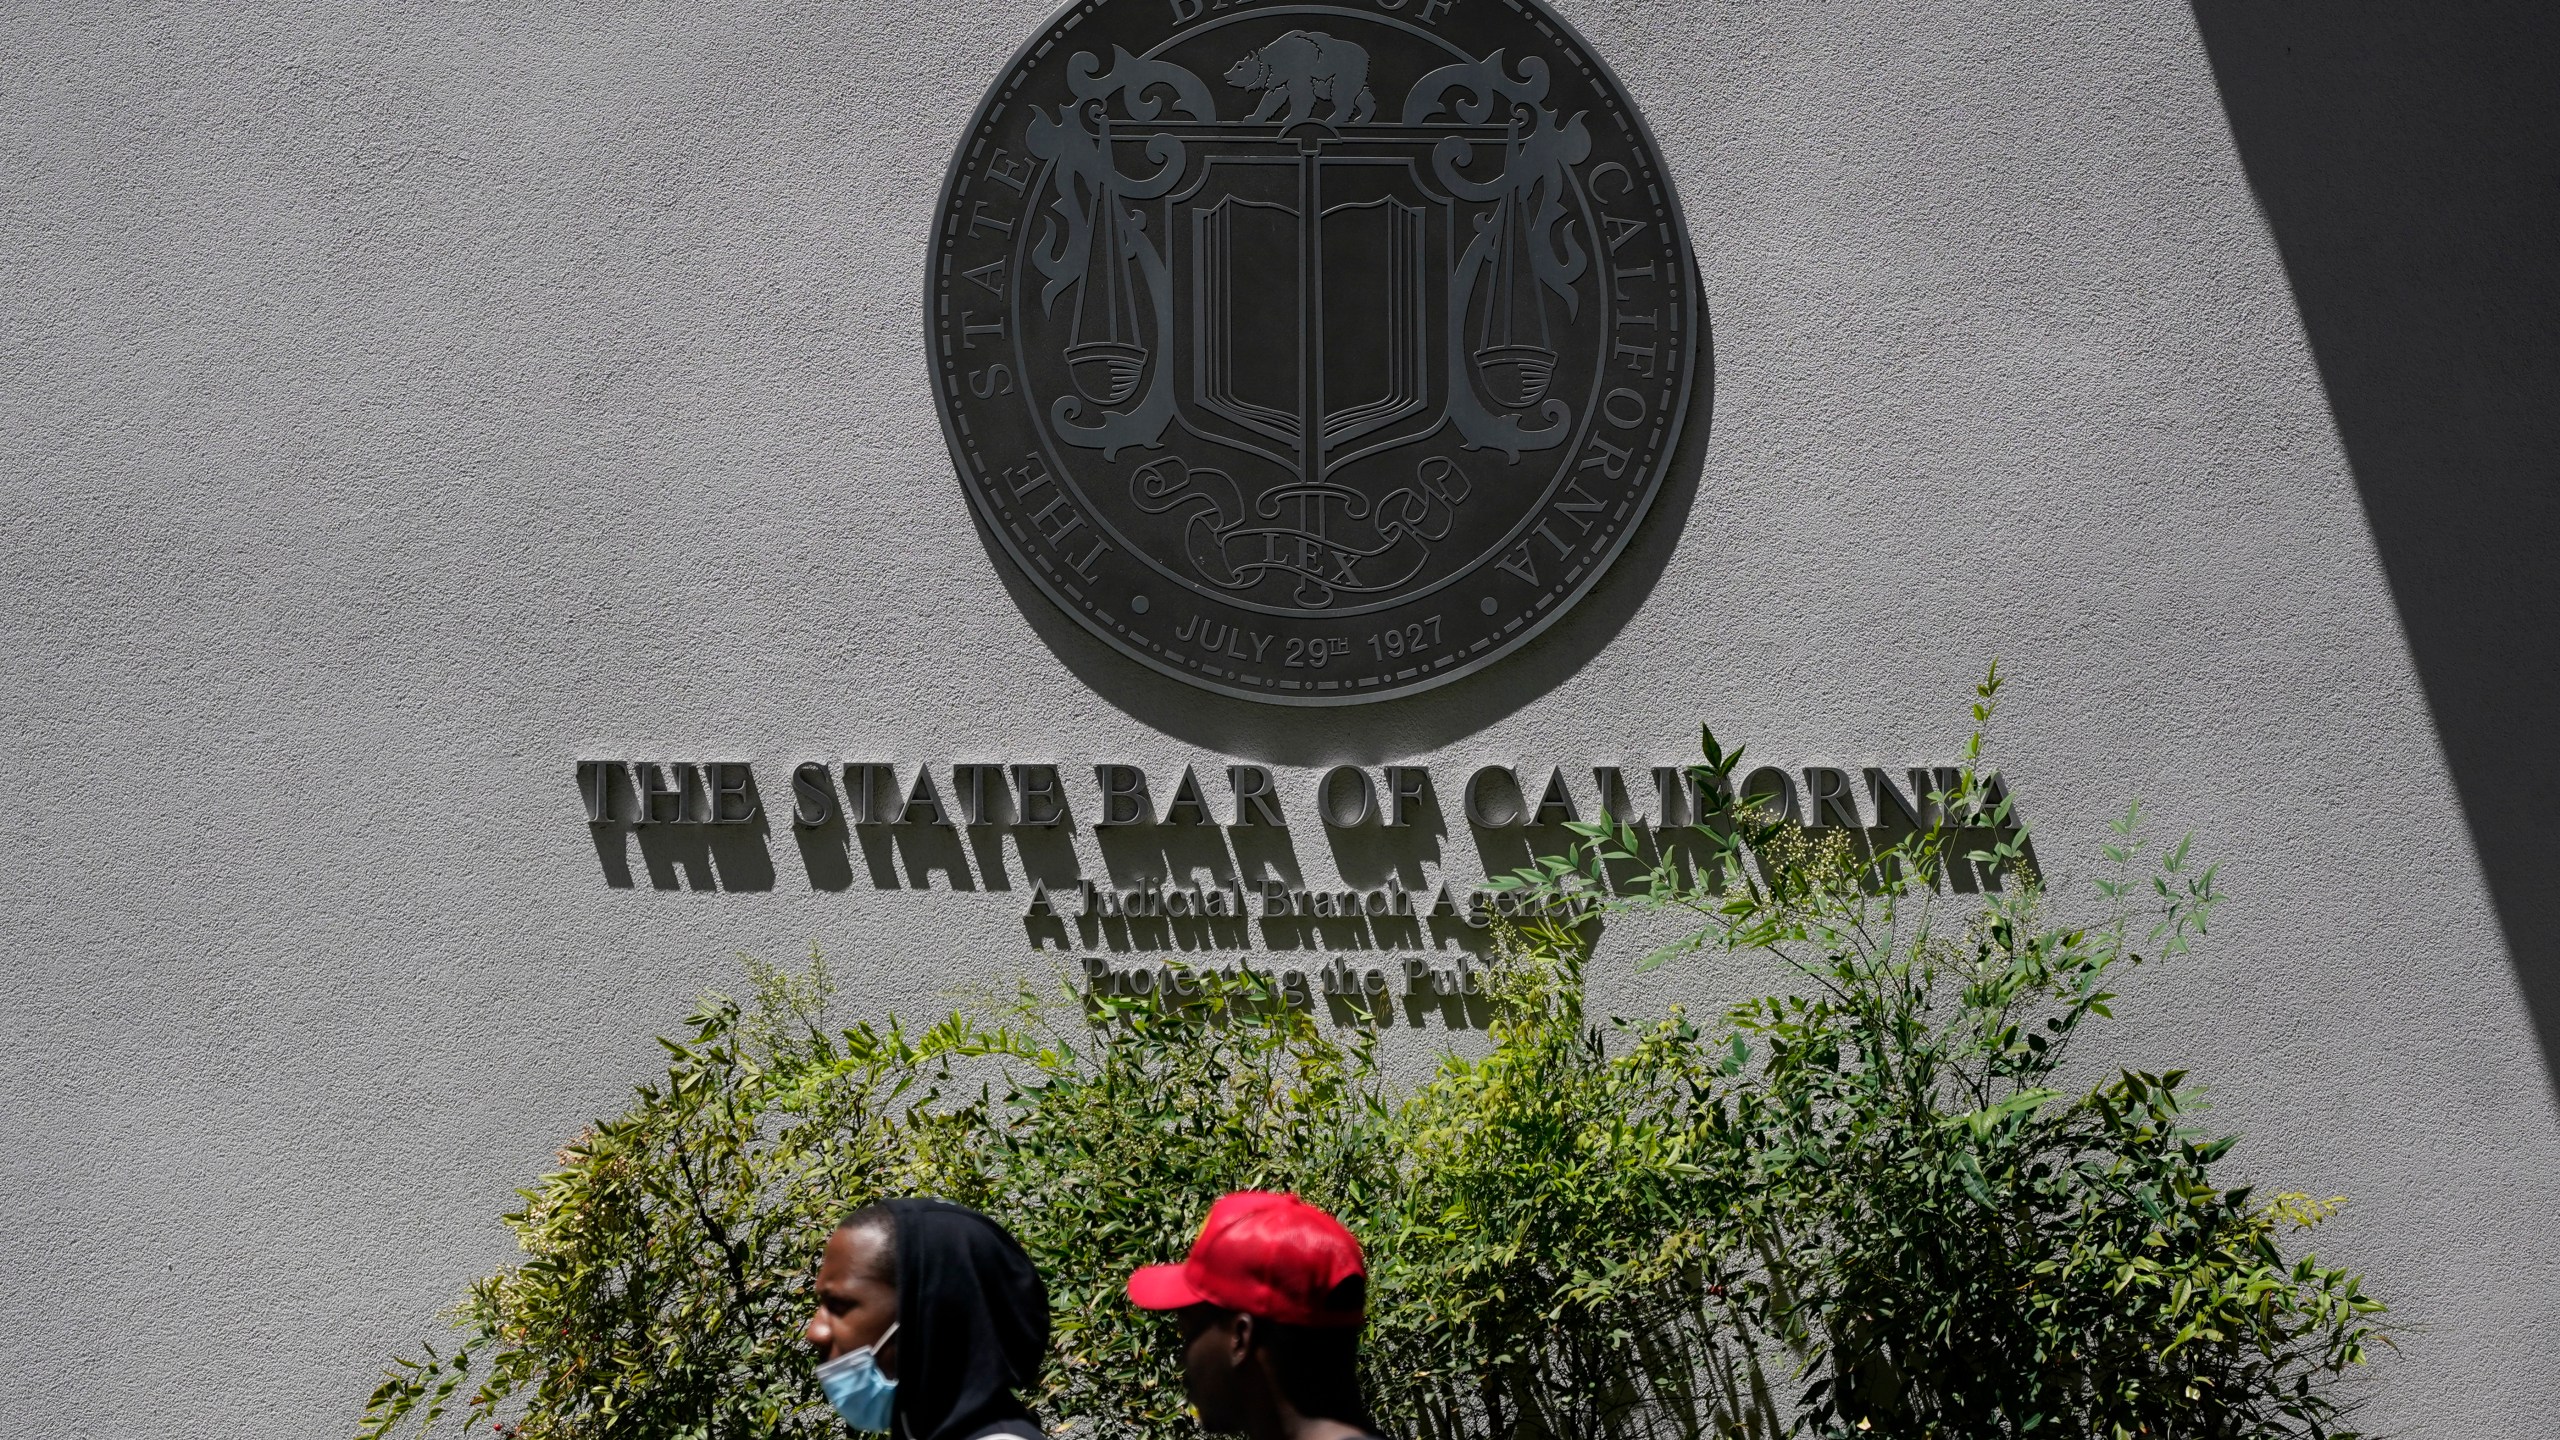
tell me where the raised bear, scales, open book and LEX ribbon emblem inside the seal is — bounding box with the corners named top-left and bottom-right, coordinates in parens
top-left (1027, 33), bottom-right (1587, 610)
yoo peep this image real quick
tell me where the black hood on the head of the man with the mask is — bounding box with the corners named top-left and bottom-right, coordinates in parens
top-left (888, 1199), bottom-right (1050, 1440)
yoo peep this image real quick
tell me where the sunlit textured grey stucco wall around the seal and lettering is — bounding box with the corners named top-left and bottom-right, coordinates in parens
top-left (0, 0), bottom-right (2560, 1440)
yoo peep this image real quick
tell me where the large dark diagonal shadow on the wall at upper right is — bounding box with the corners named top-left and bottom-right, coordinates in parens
top-left (2194, 0), bottom-right (2560, 1076)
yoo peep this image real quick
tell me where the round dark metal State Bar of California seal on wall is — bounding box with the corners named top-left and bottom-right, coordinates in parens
top-left (924, 0), bottom-right (1697, 705)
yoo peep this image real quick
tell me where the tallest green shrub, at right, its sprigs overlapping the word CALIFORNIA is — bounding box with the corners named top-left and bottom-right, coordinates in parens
top-left (1503, 666), bottom-right (2383, 1440)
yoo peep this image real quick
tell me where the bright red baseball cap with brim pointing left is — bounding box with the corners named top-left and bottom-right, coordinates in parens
top-left (1129, 1189), bottom-right (1370, 1325)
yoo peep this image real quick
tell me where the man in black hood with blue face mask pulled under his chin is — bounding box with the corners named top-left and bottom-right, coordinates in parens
top-left (804, 1199), bottom-right (1050, 1440)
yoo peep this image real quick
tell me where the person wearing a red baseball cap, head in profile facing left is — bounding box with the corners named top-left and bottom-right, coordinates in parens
top-left (1129, 1191), bottom-right (1375, 1440)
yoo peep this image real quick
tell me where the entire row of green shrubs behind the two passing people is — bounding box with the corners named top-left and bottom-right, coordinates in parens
top-left (361, 671), bottom-right (2381, 1440)
